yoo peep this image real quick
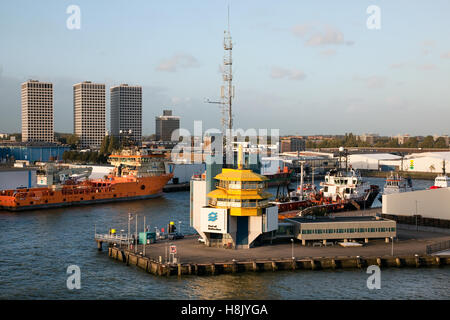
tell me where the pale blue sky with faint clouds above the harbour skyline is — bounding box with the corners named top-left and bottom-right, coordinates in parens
top-left (0, 0), bottom-right (450, 135)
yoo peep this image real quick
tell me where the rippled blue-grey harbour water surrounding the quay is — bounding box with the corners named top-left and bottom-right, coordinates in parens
top-left (0, 178), bottom-right (450, 299)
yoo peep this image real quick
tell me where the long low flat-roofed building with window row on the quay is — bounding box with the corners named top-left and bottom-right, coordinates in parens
top-left (284, 216), bottom-right (397, 245)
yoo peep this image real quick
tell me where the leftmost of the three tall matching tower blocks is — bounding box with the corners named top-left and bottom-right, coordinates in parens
top-left (21, 80), bottom-right (54, 142)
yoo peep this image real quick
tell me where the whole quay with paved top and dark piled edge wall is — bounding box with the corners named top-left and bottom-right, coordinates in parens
top-left (103, 230), bottom-right (450, 276)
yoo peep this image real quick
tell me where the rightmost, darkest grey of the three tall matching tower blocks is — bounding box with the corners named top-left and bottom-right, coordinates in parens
top-left (110, 84), bottom-right (142, 145)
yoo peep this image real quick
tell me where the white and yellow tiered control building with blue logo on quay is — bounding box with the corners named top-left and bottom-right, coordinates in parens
top-left (191, 146), bottom-right (278, 249)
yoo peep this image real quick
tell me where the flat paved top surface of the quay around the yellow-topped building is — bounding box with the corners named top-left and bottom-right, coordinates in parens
top-left (125, 230), bottom-right (450, 264)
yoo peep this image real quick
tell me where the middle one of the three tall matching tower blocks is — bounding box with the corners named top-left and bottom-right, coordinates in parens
top-left (73, 81), bottom-right (106, 149)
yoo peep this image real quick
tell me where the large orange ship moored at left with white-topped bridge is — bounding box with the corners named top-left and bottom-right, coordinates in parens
top-left (0, 150), bottom-right (173, 211)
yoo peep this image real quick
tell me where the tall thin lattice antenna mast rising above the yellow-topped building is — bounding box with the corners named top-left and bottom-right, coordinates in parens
top-left (206, 6), bottom-right (234, 162)
